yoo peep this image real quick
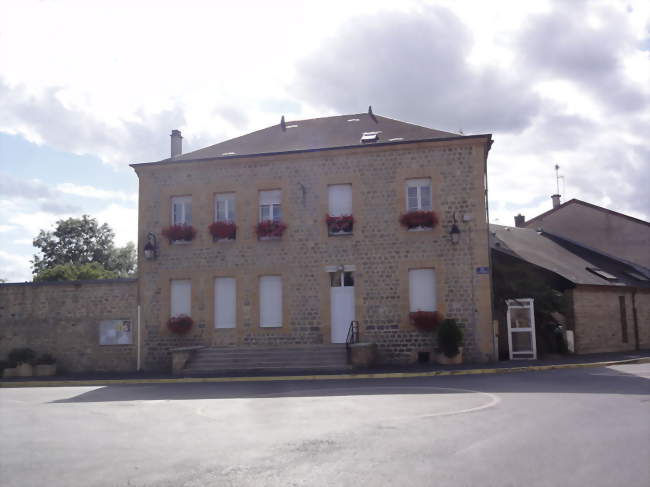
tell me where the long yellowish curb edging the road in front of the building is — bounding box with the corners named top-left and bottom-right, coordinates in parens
top-left (0, 357), bottom-right (650, 388)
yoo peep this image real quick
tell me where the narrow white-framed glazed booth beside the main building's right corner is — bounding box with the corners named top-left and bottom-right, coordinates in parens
top-left (506, 298), bottom-right (537, 360)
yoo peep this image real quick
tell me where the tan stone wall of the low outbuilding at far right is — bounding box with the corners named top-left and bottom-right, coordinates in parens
top-left (571, 286), bottom-right (650, 353)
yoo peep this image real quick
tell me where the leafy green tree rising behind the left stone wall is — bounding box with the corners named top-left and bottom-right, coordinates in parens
top-left (32, 215), bottom-right (136, 281)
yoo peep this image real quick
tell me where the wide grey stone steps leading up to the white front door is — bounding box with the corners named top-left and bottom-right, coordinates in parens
top-left (183, 344), bottom-right (348, 376)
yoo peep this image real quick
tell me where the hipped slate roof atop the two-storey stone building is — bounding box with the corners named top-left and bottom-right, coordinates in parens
top-left (161, 113), bottom-right (464, 162)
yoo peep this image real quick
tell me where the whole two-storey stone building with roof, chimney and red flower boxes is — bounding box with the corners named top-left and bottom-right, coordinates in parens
top-left (132, 110), bottom-right (494, 370)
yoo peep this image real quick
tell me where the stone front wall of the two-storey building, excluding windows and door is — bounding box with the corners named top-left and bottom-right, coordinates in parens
top-left (134, 136), bottom-right (493, 369)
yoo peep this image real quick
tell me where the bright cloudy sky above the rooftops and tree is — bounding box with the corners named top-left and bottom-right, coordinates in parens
top-left (0, 0), bottom-right (650, 282)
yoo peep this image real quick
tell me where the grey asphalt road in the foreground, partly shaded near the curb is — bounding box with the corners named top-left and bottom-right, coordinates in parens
top-left (0, 364), bottom-right (650, 487)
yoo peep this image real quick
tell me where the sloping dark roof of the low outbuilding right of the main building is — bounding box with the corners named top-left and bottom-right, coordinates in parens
top-left (490, 224), bottom-right (650, 288)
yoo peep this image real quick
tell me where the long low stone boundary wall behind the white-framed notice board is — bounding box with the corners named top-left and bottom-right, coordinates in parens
top-left (0, 279), bottom-right (137, 373)
